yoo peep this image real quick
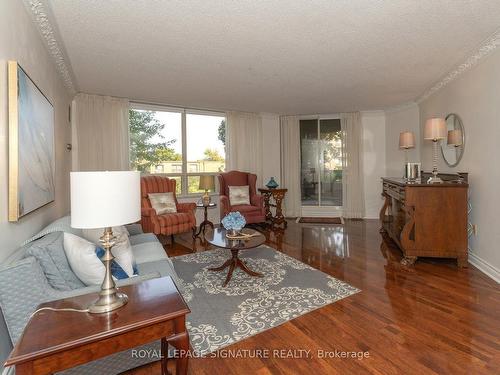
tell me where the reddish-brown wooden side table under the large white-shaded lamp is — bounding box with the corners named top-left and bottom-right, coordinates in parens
top-left (5, 277), bottom-right (190, 375)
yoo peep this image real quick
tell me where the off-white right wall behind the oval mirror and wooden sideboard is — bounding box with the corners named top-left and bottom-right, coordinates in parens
top-left (419, 50), bottom-right (500, 282)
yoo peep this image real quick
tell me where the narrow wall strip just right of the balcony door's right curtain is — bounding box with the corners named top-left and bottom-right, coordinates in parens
top-left (361, 111), bottom-right (386, 219)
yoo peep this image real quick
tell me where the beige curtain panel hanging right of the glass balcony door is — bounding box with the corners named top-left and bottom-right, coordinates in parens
top-left (340, 112), bottom-right (365, 218)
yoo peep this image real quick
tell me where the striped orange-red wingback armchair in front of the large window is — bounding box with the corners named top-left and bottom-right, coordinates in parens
top-left (141, 176), bottom-right (196, 236)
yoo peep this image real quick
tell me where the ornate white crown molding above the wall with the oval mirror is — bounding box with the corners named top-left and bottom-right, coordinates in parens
top-left (416, 29), bottom-right (500, 103)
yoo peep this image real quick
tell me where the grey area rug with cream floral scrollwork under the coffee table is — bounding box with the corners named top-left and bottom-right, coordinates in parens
top-left (171, 246), bottom-right (359, 355)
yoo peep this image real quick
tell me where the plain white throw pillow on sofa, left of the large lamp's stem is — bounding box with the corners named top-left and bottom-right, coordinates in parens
top-left (64, 232), bottom-right (106, 285)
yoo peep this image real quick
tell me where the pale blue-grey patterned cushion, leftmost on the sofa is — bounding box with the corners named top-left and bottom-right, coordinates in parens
top-left (26, 232), bottom-right (85, 290)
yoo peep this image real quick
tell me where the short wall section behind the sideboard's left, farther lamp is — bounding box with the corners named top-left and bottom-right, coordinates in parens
top-left (385, 103), bottom-right (421, 177)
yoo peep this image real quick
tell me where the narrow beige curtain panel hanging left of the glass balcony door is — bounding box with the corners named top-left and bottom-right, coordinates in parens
top-left (280, 116), bottom-right (301, 217)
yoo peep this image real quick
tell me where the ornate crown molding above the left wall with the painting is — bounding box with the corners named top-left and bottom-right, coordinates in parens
top-left (23, 0), bottom-right (77, 95)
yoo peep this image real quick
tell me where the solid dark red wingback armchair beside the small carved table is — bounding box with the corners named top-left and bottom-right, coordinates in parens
top-left (217, 171), bottom-right (266, 224)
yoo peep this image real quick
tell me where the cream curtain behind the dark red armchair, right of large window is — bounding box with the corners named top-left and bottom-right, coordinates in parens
top-left (226, 112), bottom-right (262, 187)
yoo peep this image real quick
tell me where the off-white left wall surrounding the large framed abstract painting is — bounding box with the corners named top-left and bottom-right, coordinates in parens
top-left (0, 0), bottom-right (71, 261)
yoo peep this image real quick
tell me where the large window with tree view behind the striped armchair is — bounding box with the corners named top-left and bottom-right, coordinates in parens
top-left (130, 104), bottom-right (226, 195)
